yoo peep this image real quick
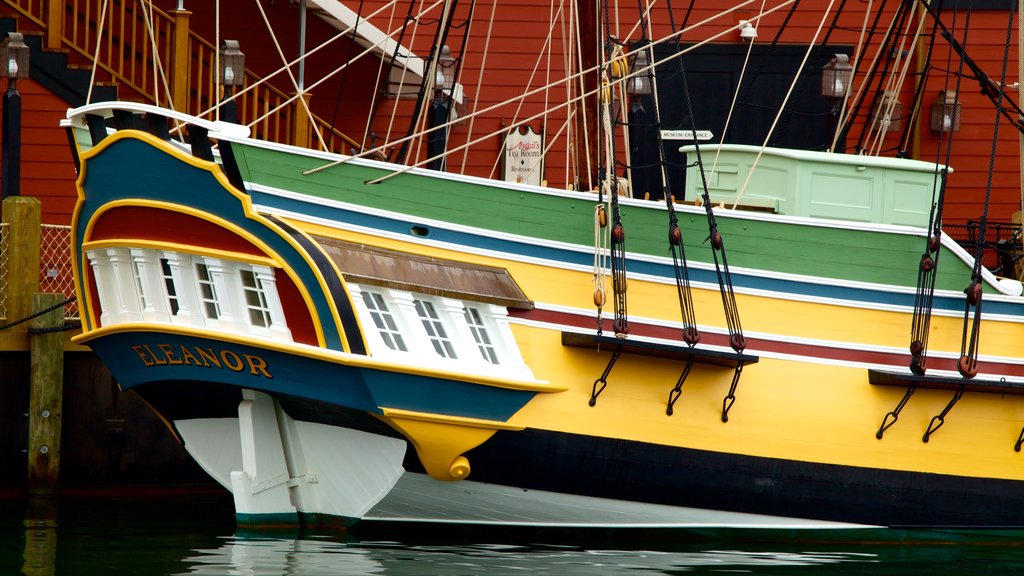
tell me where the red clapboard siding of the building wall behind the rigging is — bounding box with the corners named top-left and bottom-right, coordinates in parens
top-left (8, 0), bottom-right (1021, 223)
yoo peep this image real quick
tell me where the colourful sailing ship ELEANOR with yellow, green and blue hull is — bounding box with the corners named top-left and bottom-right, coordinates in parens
top-left (66, 2), bottom-right (1024, 531)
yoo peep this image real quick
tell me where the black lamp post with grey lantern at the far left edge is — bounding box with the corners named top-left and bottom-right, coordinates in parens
top-left (0, 32), bottom-right (29, 198)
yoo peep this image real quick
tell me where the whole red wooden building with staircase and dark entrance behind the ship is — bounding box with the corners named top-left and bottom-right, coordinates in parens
top-left (4, 0), bottom-right (1021, 229)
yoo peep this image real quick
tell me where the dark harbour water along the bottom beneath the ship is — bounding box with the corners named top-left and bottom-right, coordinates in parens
top-left (6, 494), bottom-right (1024, 576)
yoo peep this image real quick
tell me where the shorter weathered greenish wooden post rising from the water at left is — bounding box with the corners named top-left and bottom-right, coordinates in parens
top-left (29, 293), bottom-right (65, 494)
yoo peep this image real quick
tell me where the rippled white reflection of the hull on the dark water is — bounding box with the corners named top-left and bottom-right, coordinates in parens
top-left (182, 537), bottom-right (880, 576)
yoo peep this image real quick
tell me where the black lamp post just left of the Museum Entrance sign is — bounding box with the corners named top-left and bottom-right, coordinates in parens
top-left (626, 43), bottom-right (662, 198)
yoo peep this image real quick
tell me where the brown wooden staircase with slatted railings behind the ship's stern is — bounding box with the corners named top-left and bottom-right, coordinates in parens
top-left (0, 0), bottom-right (359, 154)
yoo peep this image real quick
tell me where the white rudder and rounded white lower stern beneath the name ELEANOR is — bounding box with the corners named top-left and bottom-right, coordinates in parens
top-left (174, 390), bottom-right (406, 524)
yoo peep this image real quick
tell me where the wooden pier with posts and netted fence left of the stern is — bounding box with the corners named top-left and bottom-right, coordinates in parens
top-left (0, 196), bottom-right (211, 487)
